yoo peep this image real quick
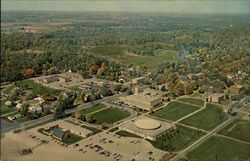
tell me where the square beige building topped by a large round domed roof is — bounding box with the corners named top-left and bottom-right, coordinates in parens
top-left (119, 116), bottom-right (176, 140)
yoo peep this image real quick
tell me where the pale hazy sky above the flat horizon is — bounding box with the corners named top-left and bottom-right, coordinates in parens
top-left (1, 0), bottom-right (250, 14)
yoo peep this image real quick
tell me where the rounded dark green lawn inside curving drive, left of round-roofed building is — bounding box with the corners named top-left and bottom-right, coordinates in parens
top-left (92, 108), bottom-right (130, 124)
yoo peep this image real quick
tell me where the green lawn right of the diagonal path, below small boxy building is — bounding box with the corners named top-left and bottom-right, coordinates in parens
top-left (181, 103), bottom-right (228, 130)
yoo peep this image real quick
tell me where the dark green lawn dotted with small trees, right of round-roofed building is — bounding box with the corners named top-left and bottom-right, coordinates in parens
top-left (148, 126), bottom-right (204, 151)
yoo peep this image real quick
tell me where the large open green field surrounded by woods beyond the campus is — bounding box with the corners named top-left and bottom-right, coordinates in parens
top-left (90, 45), bottom-right (178, 68)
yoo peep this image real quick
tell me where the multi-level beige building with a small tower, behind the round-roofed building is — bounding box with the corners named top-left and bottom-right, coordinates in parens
top-left (120, 88), bottom-right (162, 111)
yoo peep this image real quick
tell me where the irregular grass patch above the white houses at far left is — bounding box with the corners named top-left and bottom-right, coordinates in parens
top-left (16, 79), bottom-right (61, 95)
